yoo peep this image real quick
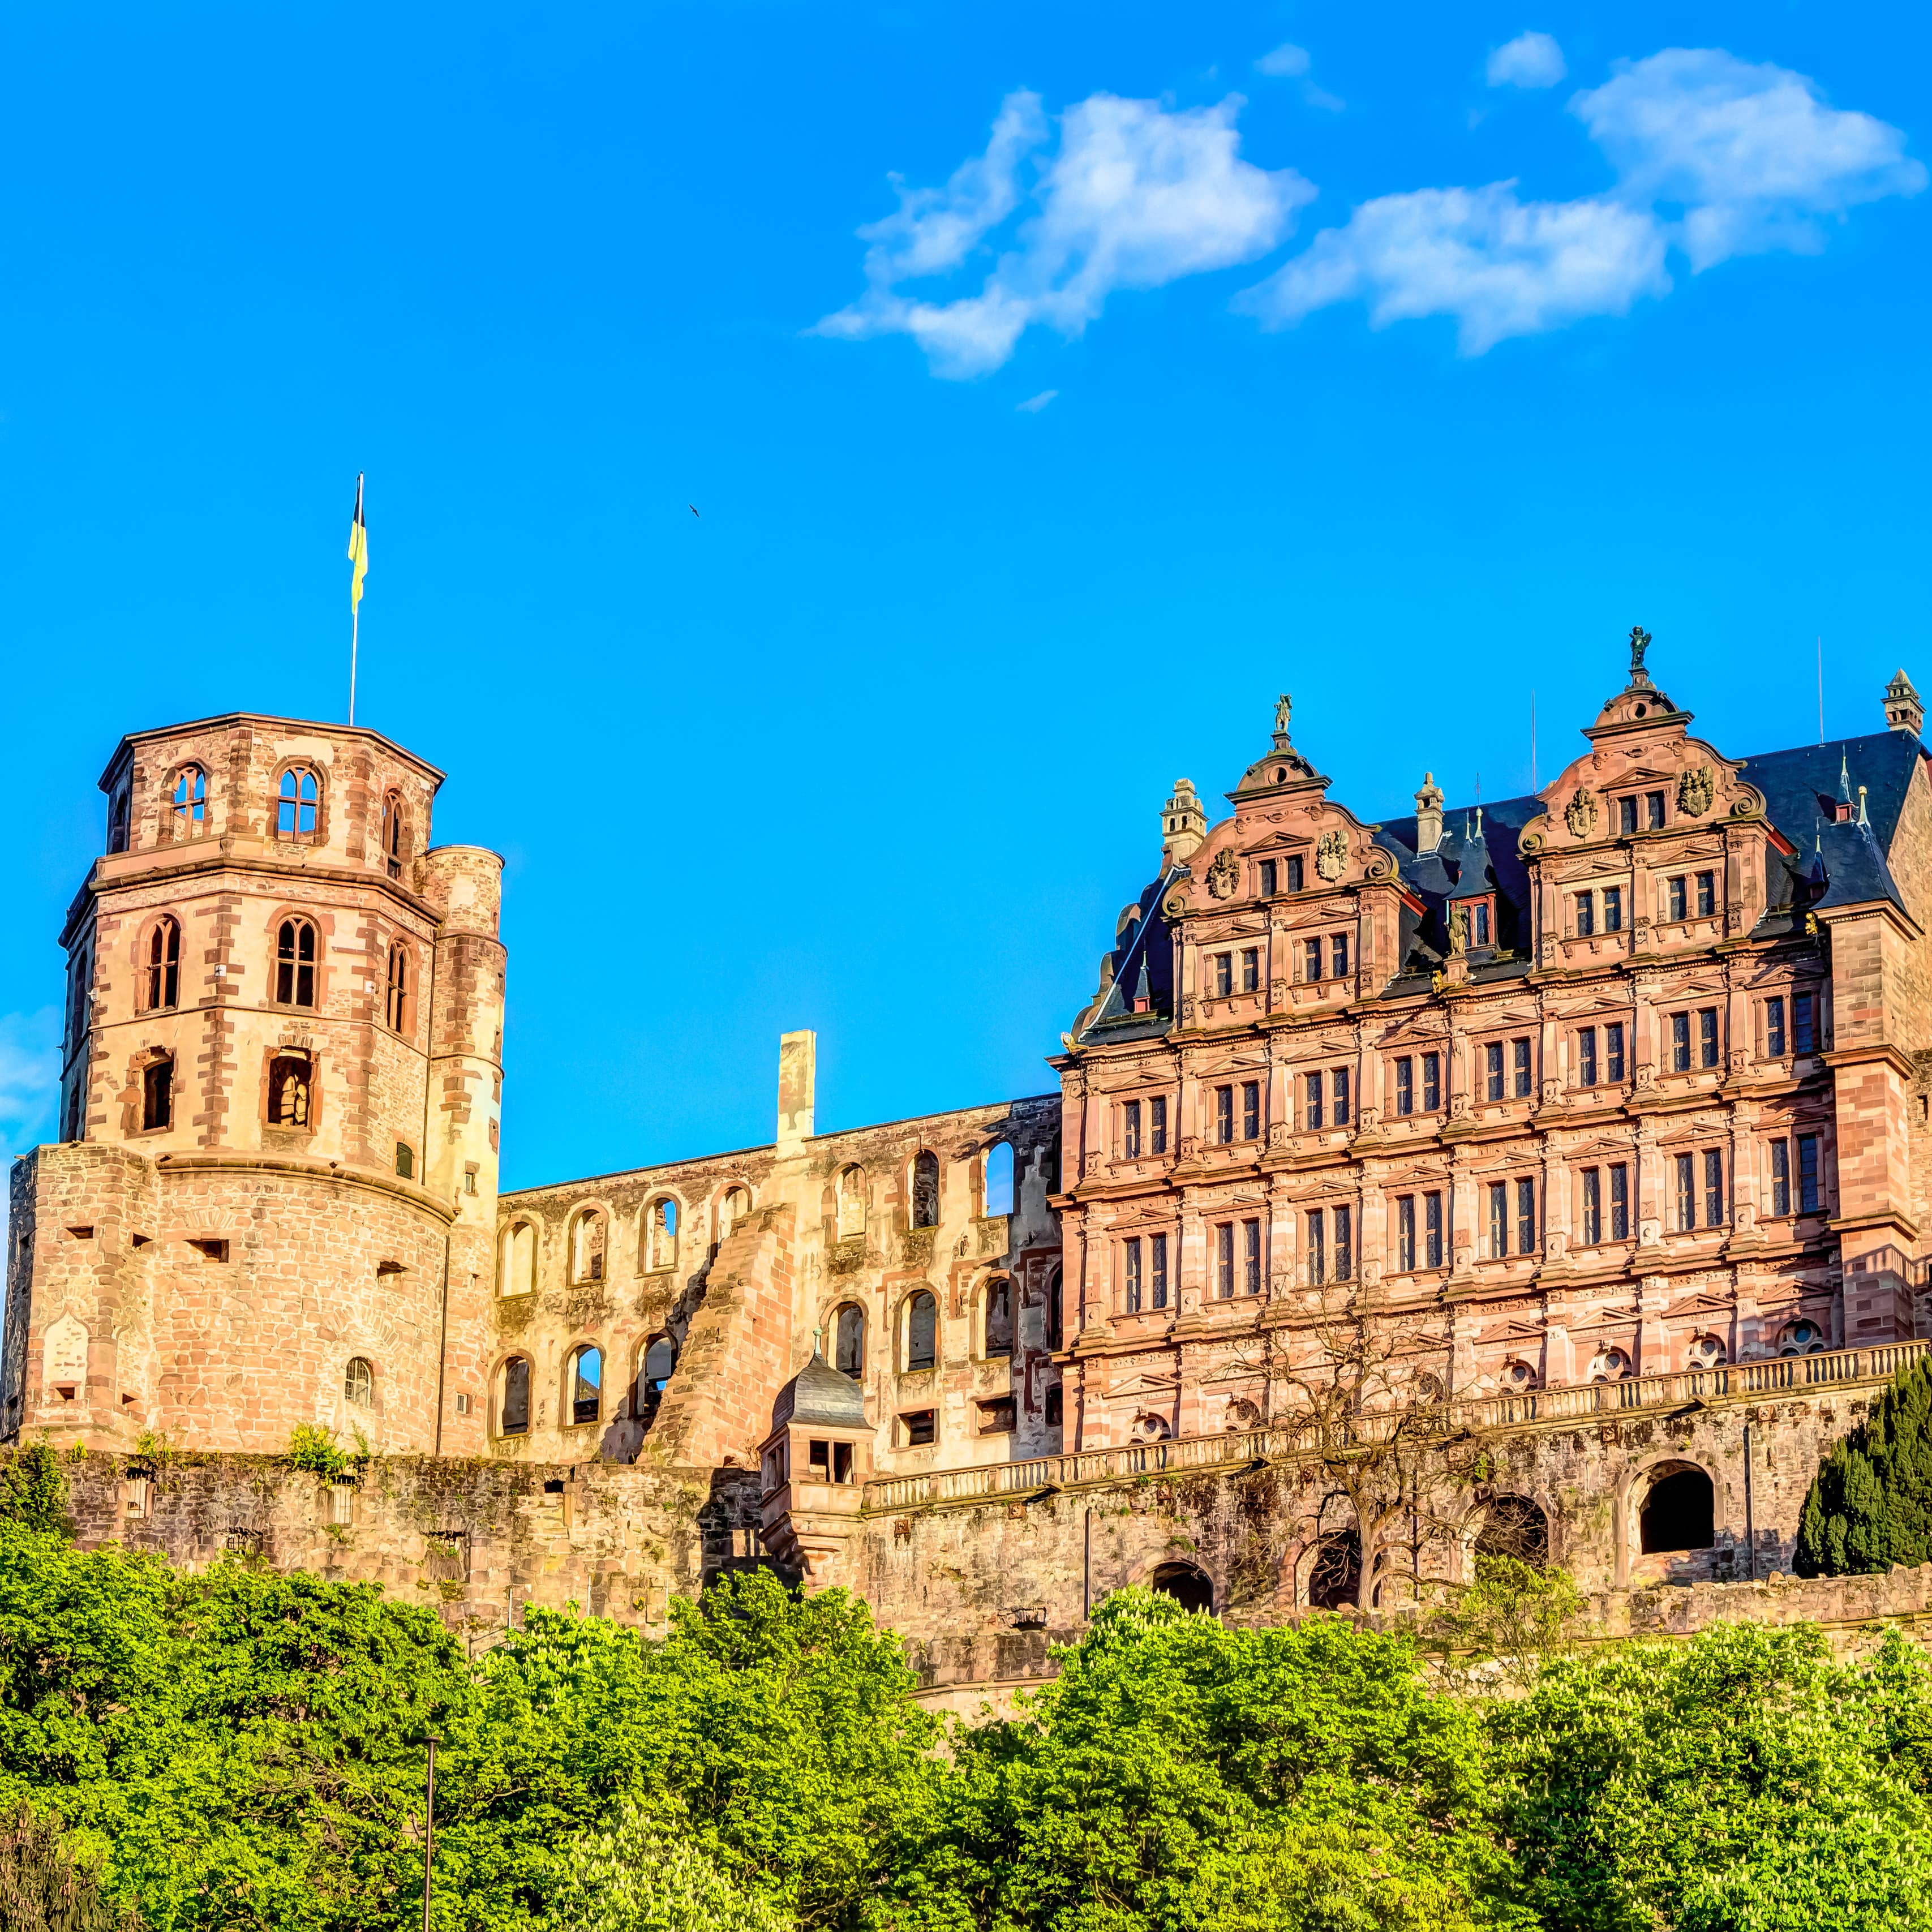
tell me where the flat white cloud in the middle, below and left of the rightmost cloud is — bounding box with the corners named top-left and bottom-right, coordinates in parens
top-left (1237, 182), bottom-right (1671, 355)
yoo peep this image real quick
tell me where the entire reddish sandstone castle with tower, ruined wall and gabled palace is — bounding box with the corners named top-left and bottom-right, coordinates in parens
top-left (11, 632), bottom-right (1932, 1681)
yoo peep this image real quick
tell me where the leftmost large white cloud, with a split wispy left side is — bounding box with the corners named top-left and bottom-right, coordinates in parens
top-left (817, 93), bottom-right (1314, 377)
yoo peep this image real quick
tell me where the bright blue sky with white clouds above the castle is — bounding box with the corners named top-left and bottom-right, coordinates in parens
top-left (0, 0), bottom-right (1932, 1184)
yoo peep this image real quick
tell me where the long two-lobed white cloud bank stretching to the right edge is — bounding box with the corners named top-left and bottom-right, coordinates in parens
top-left (1237, 48), bottom-right (1926, 355)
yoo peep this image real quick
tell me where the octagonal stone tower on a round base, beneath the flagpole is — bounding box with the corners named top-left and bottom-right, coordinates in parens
top-left (0, 713), bottom-right (504, 1453)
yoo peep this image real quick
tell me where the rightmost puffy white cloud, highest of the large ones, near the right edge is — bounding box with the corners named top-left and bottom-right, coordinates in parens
top-left (1571, 46), bottom-right (1926, 271)
